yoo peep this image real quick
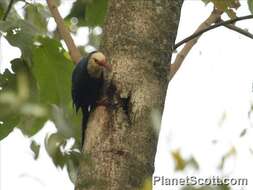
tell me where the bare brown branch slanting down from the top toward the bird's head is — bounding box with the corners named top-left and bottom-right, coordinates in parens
top-left (47, 0), bottom-right (82, 63)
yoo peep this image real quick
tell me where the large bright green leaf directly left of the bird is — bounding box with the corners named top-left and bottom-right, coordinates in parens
top-left (32, 37), bottom-right (73, 105)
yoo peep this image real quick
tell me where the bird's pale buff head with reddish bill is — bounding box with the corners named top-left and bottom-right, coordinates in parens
top-left (87, 51), bottom-right (112, 78)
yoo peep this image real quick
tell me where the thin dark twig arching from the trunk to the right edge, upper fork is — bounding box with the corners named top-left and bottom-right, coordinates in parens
top-left (174, 15), bottom-right (253, 50)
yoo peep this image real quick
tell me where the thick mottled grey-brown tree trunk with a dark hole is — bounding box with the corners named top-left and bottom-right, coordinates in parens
top-left (76, 0), bottom-right (182, 190)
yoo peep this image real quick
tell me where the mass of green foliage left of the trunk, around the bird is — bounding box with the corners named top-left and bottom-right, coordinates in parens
top-left (0, 0), bottom-right (107, 181)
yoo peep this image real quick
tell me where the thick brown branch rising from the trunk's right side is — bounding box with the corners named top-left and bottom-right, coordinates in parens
top-left (169, 9), bottom-right (223, 80)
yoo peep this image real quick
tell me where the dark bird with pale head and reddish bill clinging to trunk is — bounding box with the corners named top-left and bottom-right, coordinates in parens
top-left (71, 51), bottom-right (111, 147)
